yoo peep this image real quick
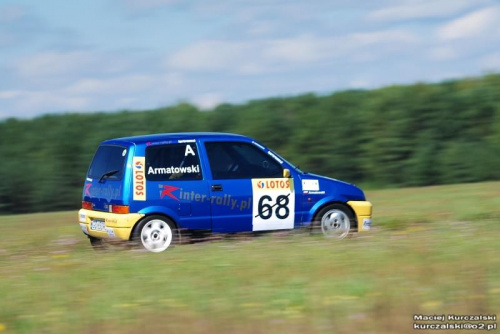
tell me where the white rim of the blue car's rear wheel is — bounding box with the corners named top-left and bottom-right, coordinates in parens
top-left (141, 219), bottom-right (172, 253)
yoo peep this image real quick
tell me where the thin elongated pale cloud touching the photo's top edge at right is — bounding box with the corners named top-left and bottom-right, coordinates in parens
top-left (368, 0), bottom-right (484, 21)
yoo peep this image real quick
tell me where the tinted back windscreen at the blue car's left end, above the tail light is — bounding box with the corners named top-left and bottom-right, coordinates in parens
top-left (88, 145), bottom-right (127, 180)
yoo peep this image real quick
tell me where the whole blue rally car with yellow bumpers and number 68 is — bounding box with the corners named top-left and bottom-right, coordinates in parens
top-left (79, 133), bottom-right (372, 252)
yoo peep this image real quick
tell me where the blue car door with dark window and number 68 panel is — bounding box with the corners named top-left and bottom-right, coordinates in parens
top-left (204, 141), bottom-right (295, 232)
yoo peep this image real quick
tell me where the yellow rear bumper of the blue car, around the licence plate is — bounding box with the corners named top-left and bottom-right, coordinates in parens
top-left (78, 209), bottom-right (144, 240)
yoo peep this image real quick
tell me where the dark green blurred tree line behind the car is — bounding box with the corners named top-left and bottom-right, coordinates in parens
top-left (0, 74), bottom-right (500, 213)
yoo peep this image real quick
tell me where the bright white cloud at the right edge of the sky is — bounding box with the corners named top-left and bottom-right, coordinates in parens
top-left (438, 6), bottom-right (500, 40)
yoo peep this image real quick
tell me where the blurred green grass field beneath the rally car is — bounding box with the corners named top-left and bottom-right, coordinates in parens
top-left (0, 182), bottom-right (500, 334)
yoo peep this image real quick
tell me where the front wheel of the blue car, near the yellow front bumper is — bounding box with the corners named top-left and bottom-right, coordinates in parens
top-left (313, 204), bottom-right (355, 239)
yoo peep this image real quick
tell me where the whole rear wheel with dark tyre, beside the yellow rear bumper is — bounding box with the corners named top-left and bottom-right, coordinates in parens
top-left (132, 216), bottom-right (180, 253)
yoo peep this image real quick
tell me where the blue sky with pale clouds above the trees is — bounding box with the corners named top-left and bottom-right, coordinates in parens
top-left (0, 0), bottom-right (500, 119)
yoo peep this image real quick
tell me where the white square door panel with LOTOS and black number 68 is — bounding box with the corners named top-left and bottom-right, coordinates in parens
top-left (252, 178), bottom-right (295, 231)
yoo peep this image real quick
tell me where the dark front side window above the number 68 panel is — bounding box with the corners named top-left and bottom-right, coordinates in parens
top-left (205, 142), bottom-right (283, 180)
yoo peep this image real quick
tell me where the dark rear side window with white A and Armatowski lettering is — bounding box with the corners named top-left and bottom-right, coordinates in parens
top-left (146, 143), bottom-right (202, 181)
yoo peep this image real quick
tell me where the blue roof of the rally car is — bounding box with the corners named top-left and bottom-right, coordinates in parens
top-left (103, 132), bottom-right (250, 144)
